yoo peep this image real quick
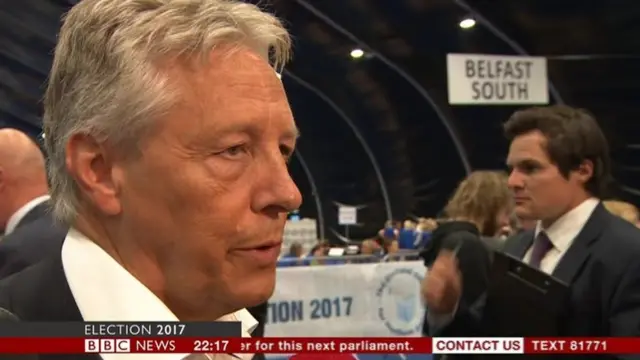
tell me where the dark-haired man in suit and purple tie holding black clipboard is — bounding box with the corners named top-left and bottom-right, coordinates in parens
top-left (425, 106), bottom-right (640, 359)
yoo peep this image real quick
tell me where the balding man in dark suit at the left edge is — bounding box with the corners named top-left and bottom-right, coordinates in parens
top-left (0, 129), bottom-right (66, 278)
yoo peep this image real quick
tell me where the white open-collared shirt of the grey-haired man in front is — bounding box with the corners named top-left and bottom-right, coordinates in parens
top-left (62, 228), bottom-right (258, 360)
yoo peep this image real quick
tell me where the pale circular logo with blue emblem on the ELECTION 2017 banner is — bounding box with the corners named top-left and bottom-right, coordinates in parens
top-left (376, 268), bottom-right (423, 336)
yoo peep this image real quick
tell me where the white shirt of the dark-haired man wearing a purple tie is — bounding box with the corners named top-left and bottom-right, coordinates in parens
top-left (427, 198), bottom-right (600, 328)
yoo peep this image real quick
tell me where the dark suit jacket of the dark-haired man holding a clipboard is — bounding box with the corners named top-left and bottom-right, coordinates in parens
top-left (436, 204), bottom-right (640, 359)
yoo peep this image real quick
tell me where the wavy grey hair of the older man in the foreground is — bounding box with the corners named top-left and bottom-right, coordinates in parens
top-left (43, 0), bottom-right (291, 223)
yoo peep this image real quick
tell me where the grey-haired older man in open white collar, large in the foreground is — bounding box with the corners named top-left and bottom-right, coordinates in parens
top-left (0, 0), bottom-right (302, 359)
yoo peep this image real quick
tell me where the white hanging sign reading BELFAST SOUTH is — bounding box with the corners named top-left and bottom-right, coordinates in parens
top-left (447, 54), bottom-right (549, 105)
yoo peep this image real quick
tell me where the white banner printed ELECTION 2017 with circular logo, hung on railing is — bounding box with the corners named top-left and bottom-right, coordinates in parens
top-left (265, 261), bottom-right (426, 337)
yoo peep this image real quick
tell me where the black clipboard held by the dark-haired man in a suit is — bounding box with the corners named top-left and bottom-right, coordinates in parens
top-left (482, 252), bottom-right (571, 337)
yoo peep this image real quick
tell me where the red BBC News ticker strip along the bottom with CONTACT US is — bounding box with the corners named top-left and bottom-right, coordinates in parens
top-left (0, 337), bottom-right (640, 354)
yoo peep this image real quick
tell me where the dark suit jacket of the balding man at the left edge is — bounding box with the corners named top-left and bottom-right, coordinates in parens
top-left (0, 201), bottom-right (67, 279)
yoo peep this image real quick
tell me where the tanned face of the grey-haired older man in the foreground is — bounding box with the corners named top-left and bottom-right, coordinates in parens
top-left (121, 49), bottom-right (301, 315)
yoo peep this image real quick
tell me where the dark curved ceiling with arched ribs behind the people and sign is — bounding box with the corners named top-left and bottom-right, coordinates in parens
top-left (0, 0), bottom-right (640, 242)
